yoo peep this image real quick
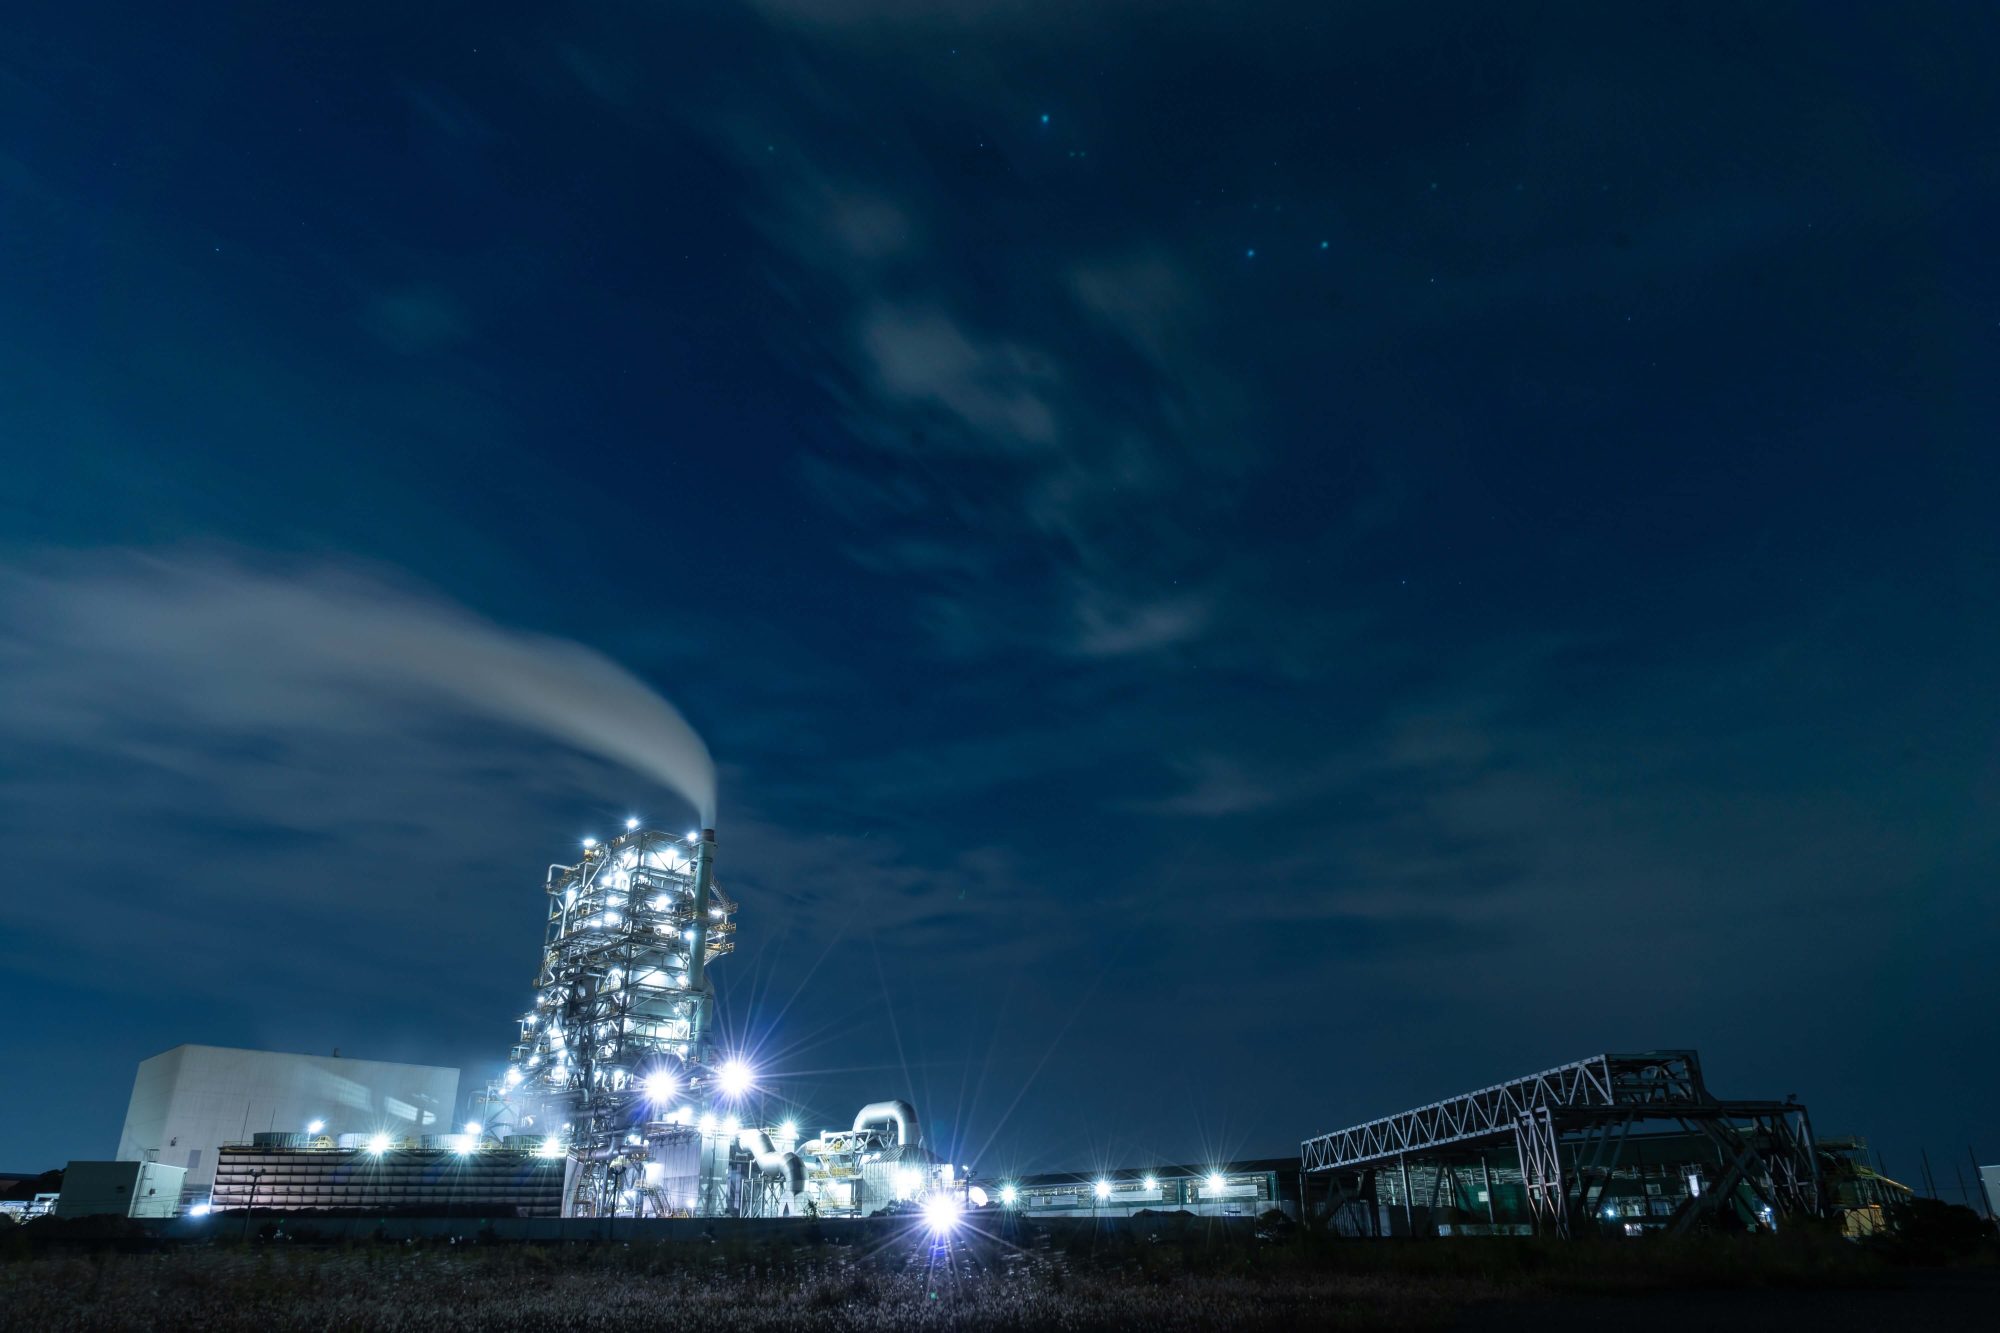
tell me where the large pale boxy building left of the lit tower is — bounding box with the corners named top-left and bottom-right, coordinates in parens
top-left (118, 1047), bottom-right (458, 1197)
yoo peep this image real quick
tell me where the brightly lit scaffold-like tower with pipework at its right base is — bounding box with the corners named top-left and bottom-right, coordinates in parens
top-left (466, 821), bottom-right (940, 1217)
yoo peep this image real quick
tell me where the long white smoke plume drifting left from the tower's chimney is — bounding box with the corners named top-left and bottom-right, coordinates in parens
top-left (0, 554), bottom-right (716, 825)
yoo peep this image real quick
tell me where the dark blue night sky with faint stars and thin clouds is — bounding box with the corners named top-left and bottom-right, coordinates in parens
top-left (0, 0), bottom-right (2000, 1179)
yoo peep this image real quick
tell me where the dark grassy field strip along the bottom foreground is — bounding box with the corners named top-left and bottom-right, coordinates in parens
top-left (0, 1225), bottom-right (1984, 1333)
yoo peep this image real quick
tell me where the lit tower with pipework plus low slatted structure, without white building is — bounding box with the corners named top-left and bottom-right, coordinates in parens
top-left (189, 821), bottom-right (968, 1219)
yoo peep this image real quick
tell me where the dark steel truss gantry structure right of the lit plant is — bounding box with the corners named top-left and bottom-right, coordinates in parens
top-left (1300, 1051), bottom-right (1822, 1235)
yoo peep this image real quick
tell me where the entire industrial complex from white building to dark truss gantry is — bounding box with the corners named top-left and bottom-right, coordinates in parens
top-left (19, 821), bottom-right (1984, 1237)
